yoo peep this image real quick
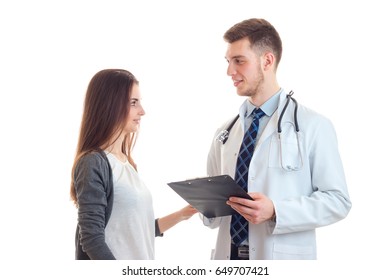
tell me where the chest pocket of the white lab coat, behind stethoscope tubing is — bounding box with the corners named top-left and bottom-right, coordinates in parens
top-left (268, 133), bottom-right (303, 171)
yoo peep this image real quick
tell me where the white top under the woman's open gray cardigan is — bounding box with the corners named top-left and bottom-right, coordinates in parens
top-left (105, 152), bottom-right (155, 260)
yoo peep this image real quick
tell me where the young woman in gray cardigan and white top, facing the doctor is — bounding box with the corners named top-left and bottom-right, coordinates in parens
top-left (71, 69), bottom-right (197, 260)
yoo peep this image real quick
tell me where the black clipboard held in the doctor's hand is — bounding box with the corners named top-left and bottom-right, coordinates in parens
top-left (168, 175), bottom-right (253, 218)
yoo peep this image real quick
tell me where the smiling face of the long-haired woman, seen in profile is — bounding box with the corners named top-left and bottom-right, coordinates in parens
top-left (124, 83), bottom-right (145, 133)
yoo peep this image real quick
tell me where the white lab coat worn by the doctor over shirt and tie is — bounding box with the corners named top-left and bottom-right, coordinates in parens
top-left (203, 91), bottom-right (351, 260)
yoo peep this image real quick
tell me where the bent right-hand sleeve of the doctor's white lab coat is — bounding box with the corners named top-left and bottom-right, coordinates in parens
top-left (273, 118), bottom-right (352, 234)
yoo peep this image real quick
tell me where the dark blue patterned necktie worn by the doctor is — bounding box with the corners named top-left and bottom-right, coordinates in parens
top-left (230, 108), bottom-right (264, 246)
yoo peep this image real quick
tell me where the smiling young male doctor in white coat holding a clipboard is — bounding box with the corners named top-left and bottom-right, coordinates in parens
top-left (203, 19), bottom-right (351, 260)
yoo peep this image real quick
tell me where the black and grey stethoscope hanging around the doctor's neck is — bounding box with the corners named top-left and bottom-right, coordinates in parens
top-left (216, 90), bottom-right (303, 171)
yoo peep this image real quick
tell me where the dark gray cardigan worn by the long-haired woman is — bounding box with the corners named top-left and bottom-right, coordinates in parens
top-left (74, 150), bottom-right (162, 260)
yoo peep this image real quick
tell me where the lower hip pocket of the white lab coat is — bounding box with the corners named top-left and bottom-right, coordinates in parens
top-left (273, 243), bottom-right (316, 260)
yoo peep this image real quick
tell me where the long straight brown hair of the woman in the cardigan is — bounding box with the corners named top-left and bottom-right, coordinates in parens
top-left (70, 69), bottom-right (138, 205)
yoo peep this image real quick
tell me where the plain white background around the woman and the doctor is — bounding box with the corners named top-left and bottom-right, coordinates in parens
top-left (0, 0), bottom-right (390, 279)
